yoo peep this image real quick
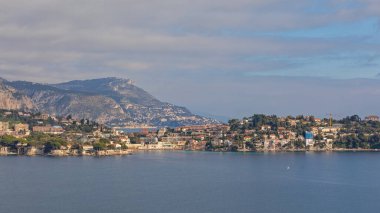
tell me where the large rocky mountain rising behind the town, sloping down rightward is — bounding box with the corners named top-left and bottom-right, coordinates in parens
top-left (0, 78), bottom-right (218, 126)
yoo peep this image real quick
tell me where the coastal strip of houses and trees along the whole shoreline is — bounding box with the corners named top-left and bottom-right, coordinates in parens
top-left (0, 110), bottom-right (380, 156)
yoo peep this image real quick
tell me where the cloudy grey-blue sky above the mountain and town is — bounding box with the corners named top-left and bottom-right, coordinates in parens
top-left (0, 0), bottom-right (380, 118)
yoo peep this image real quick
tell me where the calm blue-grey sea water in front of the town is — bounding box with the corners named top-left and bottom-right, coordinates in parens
top-left (0, 152), bottom-right (380, 213)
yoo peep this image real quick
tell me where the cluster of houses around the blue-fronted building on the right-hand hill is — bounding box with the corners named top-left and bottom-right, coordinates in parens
top-left (232, 116), bottom-right (342, 151)
